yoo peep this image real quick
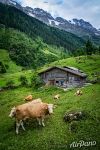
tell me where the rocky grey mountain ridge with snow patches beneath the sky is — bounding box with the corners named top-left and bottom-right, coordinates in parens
top-left (0, 0), bottom-right (100, 45)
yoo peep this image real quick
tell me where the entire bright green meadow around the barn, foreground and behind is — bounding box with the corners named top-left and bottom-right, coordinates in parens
top-left (0, 50), bottom-right (100, 150)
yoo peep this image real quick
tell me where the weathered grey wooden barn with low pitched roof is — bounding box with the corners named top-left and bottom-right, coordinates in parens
top-left (39, 66), bottom-right (87, 88)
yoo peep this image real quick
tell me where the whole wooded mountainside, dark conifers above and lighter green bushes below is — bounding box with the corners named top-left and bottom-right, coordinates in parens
top-left (0, 3), bottom-right (84, 68)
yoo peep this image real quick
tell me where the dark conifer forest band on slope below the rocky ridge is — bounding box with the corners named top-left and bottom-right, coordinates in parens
top-left (0, 3), bottom-right (84, 51)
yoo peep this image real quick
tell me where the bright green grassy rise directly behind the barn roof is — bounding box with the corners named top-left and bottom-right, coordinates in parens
top-left (39, 55), bottom-right (100, 79)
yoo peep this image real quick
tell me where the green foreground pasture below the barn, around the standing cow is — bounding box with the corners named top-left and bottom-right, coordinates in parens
top-left (0, 84), bottom-right (100, 150)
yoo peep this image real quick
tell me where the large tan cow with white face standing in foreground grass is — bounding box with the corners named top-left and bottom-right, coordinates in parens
top-left (9, 101), bottom-right (53, 134)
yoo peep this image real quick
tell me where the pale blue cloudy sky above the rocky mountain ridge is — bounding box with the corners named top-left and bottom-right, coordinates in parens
top-left (16, 0), bottom-right (100, 28)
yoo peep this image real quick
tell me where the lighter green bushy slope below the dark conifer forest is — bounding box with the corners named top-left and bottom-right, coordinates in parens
top-left (0, 26), bottom-right (68, 68)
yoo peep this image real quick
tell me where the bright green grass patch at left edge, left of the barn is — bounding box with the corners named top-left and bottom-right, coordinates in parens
top-left (0, 49), bottom-right (33, 87)
